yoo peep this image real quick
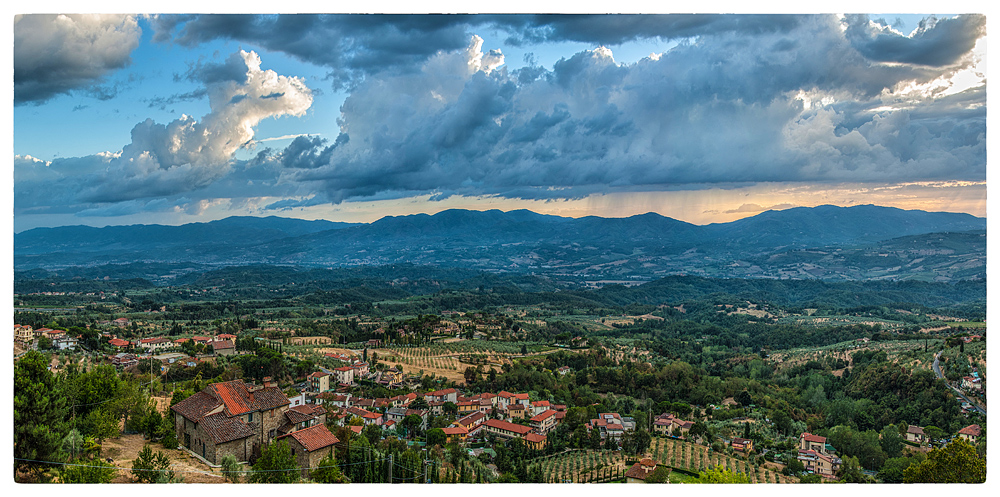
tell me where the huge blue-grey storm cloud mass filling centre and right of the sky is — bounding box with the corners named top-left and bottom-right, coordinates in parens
top-left (260, 16), bottom-right (985, 202)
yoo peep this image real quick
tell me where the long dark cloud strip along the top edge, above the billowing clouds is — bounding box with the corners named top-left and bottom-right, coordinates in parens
top-left (154, 14), bottom-right (802, 86)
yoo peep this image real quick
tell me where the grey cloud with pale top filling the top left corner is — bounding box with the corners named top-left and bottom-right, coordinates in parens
top-left (14, 14), bottom-right (142, 105)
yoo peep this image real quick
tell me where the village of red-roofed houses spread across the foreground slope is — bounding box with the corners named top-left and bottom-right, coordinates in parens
top-left (14, 312), bottom-right (981, 483)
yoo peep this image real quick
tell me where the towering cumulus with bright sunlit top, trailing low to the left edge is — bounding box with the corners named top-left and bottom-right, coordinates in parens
top-left (14, 51), bottom-right (312, 212)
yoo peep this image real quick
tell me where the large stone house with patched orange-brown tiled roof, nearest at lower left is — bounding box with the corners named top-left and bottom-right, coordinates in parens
top-left (170, 378), bottom-right (289, 465)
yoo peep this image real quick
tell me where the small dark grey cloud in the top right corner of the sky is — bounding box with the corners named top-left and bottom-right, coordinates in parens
top-left (846, 14), bottom-right (986, 66)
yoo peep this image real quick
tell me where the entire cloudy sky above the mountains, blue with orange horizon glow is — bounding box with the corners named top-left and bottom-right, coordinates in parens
top-left (12, 9), bottom-right (986, 232)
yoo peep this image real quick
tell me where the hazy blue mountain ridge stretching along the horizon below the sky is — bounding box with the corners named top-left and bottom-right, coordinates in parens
top-left (14, 205), bottom-right (986, 279)
